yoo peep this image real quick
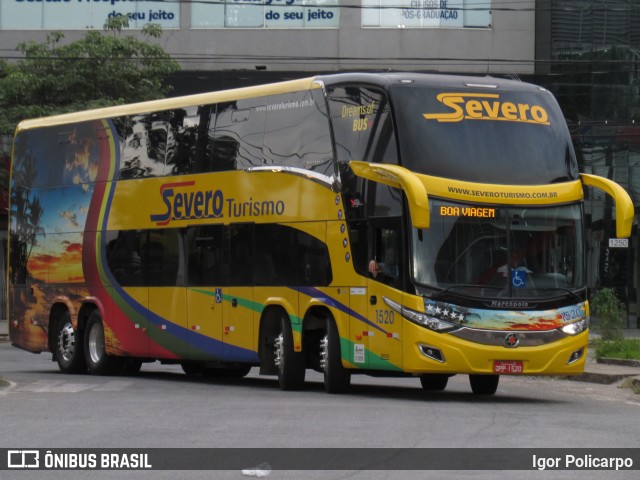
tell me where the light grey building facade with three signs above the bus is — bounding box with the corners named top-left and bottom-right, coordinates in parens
top-left (0, 0), bottom-right (535, 74)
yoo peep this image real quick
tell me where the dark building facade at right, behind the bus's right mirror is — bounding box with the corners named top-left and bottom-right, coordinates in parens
top-left (534, 0), bottom-right (640, 327)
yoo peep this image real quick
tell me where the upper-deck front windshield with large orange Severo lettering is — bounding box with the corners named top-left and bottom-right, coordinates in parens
top-left (392, 85), bottom-right (579, 185)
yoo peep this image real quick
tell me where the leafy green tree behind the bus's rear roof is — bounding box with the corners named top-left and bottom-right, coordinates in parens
top-left (0, 16), bottom-right (180, 135)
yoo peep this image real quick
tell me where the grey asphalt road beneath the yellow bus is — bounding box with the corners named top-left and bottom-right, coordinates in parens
top-left (0, 343), bottom-right (640, 480)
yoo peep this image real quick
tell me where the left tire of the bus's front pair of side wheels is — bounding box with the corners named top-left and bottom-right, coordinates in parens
top-left (273, 315), bottom-right (306, 390)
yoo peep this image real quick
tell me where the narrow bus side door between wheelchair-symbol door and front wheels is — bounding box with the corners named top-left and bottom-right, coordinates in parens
top-left (223, 224), bottom-right (255, 361)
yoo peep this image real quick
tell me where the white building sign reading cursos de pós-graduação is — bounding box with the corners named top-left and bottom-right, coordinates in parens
top-left (362, 0), bottom-right (491, 28)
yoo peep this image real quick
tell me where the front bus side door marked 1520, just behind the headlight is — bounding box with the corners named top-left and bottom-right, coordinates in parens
top-left (367, 218), bottom-right (404, 370)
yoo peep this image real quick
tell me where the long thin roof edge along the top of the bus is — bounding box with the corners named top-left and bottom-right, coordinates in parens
top-left (16, 72), bottom-right (545, 134)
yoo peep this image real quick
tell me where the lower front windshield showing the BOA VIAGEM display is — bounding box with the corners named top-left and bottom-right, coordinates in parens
top-left (412, 199), bottom-right (585, 298)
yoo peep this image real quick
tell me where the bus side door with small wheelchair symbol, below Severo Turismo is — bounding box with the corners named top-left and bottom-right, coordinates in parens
top-left (185, 225), bottom-right (229, 361)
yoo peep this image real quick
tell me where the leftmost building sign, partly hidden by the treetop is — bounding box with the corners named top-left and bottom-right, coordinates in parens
top-left (0, 0), bottom-right (180, 30)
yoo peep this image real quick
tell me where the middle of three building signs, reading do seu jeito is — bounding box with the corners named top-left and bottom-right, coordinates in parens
top-left (191, 0), bottom-right (340, 28)
